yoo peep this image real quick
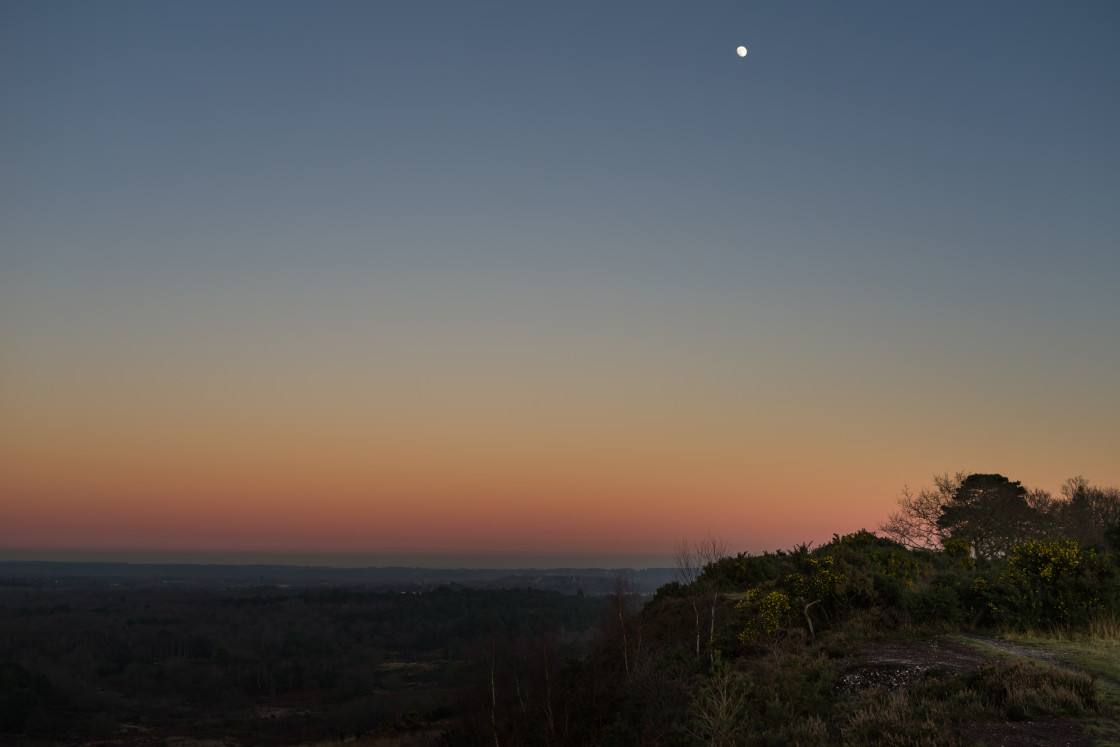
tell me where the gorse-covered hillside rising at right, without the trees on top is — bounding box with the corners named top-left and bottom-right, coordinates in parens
top-left (449, 531), bottom-right (1120, 746)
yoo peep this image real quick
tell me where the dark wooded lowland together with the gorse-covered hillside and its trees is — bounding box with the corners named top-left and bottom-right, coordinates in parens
top-left (0, 475), bottom-right (1120, 746)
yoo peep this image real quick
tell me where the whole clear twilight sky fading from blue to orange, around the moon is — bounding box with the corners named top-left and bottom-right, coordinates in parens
top-left (0, 0), bottom-right (1120, 566)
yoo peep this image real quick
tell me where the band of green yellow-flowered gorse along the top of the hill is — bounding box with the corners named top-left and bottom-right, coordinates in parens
top-left (706, 531), bottom-right (1120, 641)
